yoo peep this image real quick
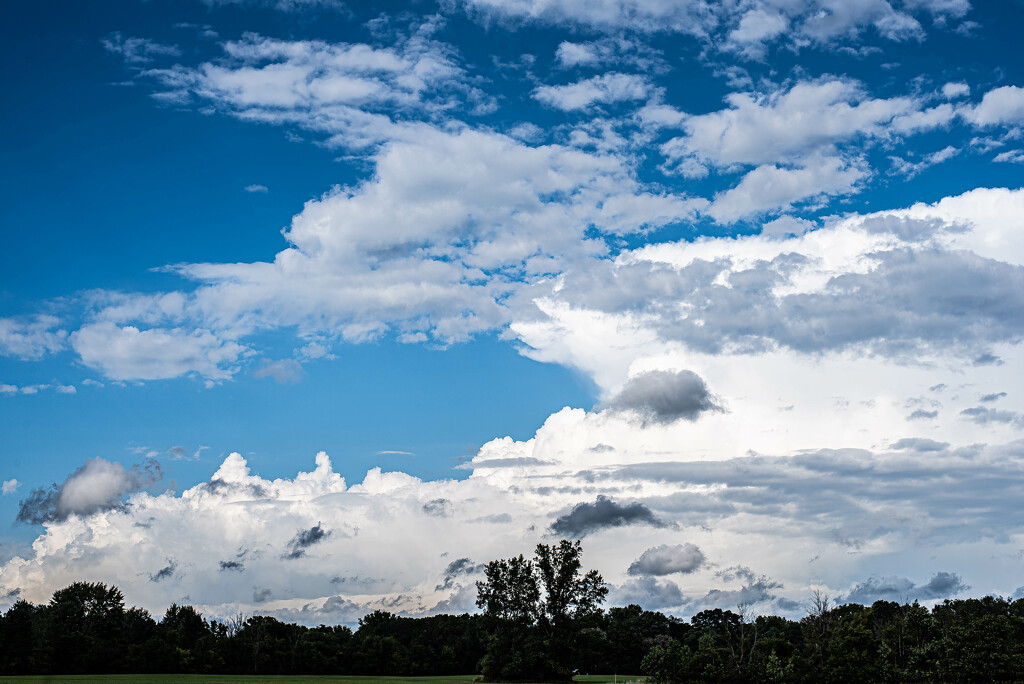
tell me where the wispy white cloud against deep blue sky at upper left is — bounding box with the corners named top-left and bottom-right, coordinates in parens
top-left (134, 28), bottom-right (481, 149)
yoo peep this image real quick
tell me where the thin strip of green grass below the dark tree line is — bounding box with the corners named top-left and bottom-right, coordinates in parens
top-left (0, 675), bottom-right (645, 684)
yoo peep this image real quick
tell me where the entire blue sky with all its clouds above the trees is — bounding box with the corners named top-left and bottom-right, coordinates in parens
top-left (0, 0), bottom-right (1024, 625)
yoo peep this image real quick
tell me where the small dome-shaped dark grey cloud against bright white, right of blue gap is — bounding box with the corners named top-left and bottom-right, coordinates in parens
top-left (607, 371), bottom-right (722, 423)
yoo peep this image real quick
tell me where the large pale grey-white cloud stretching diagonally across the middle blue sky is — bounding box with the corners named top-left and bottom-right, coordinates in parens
top-left (73, 128), bottom-right (701, 381)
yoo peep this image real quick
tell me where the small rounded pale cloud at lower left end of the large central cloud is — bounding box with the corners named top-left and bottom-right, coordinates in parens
top-left (71, 320), bottom-right (245, 381)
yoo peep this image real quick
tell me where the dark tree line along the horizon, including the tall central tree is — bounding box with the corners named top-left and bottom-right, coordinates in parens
top-left (0, 541), bottom-right (1024, 684)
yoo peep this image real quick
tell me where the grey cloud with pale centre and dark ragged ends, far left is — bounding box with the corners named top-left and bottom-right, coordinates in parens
top-left (17, 458), bottom-right (163, 524)
